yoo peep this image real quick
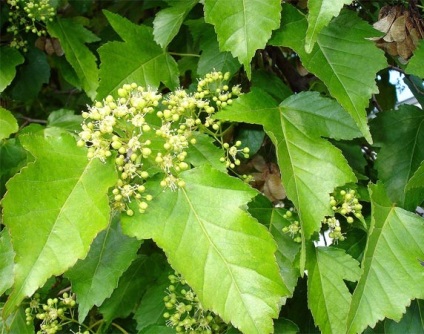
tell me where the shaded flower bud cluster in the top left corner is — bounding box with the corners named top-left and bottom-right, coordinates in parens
top-left (7, 0), bottom-right (56, 52)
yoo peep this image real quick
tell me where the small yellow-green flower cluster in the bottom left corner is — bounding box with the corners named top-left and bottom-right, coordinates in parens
top-left (25, 292), bottom-right (83, 334)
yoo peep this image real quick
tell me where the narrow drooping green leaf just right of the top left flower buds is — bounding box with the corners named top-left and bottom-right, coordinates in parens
top-left (47, 17), bottom-right (99, 100)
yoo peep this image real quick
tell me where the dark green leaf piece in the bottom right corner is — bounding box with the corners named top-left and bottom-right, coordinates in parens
top-left (384, 300), bottom-right (424, 334)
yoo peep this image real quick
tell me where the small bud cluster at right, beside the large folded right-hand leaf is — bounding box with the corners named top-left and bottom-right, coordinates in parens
top-left (322, 189), bottom-right (363, 242)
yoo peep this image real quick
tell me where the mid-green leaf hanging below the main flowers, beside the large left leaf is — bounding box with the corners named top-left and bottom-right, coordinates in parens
top-left (65, 218), bottom-right (140, 323)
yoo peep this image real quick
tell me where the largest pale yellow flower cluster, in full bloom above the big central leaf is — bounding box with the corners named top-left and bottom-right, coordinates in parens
top-left (78, 72), bottom-right (243, 216)
